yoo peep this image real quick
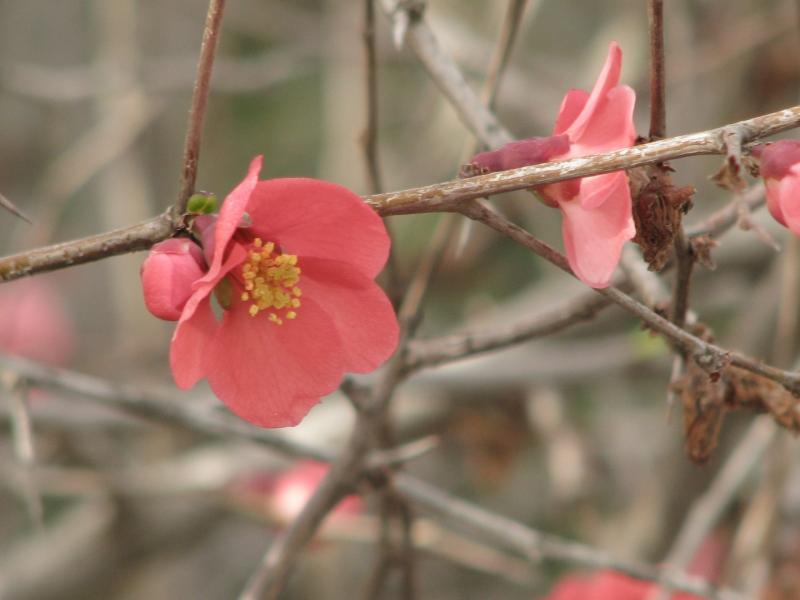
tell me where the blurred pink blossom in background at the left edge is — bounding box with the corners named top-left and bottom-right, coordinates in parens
top-left (0, 277), bottom-right (77, 365)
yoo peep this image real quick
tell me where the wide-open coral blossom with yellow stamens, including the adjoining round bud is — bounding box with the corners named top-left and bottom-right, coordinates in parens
top-left (142, 156), bottom-right (398, 427)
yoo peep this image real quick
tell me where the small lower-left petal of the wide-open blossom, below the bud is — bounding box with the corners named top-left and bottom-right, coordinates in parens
top-left (169, 294), bottom-right (219, 390)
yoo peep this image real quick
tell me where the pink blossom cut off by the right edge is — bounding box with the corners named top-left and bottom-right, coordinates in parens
top-left (752, 140), bottom-right (800, 235)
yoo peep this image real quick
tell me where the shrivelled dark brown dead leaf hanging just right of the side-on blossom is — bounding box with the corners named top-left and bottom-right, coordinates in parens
top-left (628, 164), bottom-right (695, 271)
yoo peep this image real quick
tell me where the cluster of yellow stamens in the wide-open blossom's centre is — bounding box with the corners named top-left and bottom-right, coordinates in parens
top-left (241, 238), bottom-right (302, 325)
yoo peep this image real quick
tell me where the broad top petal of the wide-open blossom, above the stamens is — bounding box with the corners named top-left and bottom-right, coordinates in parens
top-left (247, 178), bottom-right (390, 277)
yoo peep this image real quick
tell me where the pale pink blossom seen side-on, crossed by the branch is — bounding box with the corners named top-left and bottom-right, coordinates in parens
top-left (472, 42), bottom-right (636, 288)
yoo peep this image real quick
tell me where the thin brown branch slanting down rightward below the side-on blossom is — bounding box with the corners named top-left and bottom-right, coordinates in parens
top-left (465, 204), bottom-right (800, 395)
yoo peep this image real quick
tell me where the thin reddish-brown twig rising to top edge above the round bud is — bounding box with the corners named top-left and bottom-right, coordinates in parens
top-left (172, 0), bottom-right (225, 218)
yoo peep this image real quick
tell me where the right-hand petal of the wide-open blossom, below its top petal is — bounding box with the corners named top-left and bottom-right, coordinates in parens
top-left (299, 256), bottom-right (399, 373)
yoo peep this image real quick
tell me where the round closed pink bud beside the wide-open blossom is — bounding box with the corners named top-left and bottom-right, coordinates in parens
top-left (141, 238), bottom-right (205, 321)
